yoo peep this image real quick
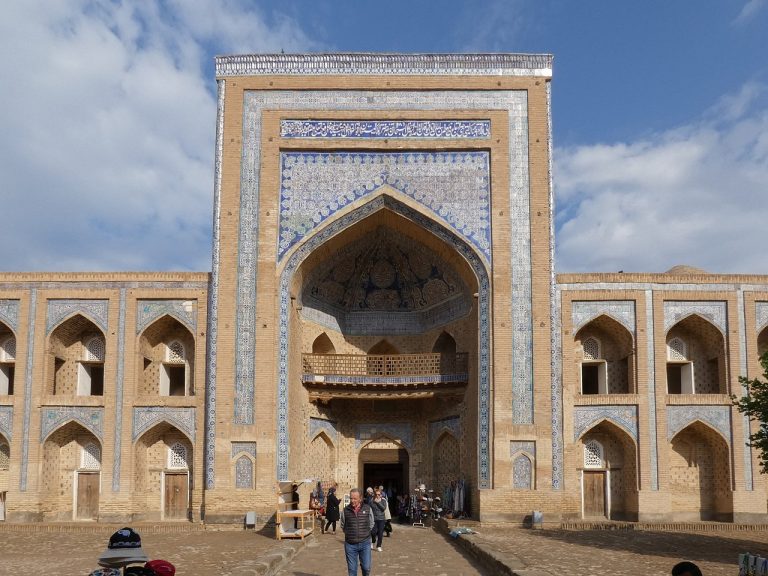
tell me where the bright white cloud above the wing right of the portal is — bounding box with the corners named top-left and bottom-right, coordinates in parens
top-left (555, 83), bottom-right (768, 273)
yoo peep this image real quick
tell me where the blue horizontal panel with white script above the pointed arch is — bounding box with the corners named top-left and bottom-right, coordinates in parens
top-left (280, 120), bottom-right (491, 140)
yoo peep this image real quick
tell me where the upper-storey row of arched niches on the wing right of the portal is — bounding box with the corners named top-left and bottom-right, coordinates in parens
top-left (557, 269), bottom-right (768, 405)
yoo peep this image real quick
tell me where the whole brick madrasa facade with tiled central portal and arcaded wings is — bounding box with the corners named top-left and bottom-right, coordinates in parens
top-left (0, 54), bottom-right (768, 524)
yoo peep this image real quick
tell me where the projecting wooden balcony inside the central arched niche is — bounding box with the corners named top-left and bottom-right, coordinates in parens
top-left (302, 353), bottom-right (469, 401)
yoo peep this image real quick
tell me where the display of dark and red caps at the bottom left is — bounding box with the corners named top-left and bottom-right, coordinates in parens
top-left (89, 528), bottom-right (176, 576)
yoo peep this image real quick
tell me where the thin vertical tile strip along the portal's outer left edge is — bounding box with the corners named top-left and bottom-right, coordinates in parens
top-left (204, 80), bottom-right (226, 489)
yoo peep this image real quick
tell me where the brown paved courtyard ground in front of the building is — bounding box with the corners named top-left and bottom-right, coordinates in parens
top-left (0, 525), bottom-right (768, 576)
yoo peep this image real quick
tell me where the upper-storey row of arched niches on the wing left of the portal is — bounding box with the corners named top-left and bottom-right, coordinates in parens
top-left (0, 274), bottom-right (207, 406)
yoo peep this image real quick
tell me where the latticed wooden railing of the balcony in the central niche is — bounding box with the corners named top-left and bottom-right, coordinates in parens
top-left (302, 352), bottom-right (468, 376)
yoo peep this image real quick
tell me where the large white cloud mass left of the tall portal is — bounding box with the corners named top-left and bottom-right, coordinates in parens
top-left (0, 0), bottom-right (314, 271)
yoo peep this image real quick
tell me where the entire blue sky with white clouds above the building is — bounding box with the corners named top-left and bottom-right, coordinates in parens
top-left (0, 0), bottom-right (768, 274)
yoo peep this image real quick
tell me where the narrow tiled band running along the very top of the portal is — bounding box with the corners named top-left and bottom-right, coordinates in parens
top-left (216, 54), bottom-right (552, 77)
